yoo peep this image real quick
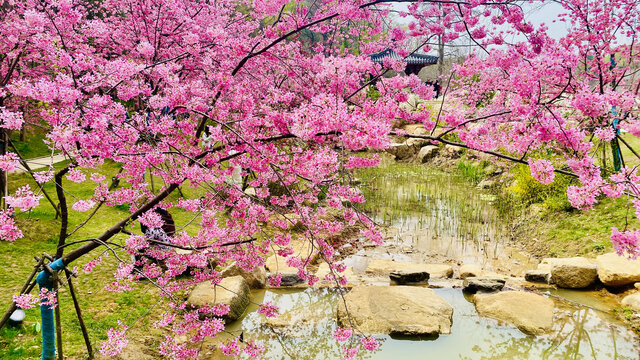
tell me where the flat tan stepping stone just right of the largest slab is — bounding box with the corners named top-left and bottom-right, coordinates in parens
top-left (474, 291), bottom-right (553, 335)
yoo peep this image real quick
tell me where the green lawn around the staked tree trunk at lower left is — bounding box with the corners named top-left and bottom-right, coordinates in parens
top-left (0, 163), bottom-right (210, 360)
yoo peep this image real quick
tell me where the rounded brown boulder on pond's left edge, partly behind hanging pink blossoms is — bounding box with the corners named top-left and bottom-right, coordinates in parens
top-left (187, 275), bottom-right (251, 321)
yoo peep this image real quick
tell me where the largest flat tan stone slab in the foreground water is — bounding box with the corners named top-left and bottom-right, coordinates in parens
top-left (338, 286), bottom-right (453, 335)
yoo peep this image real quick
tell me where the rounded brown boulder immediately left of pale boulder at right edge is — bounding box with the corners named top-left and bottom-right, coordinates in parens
top-left (551, 257), bottom-right (598, 289)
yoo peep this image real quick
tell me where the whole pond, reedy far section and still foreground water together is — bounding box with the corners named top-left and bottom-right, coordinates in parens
top-left (216, 161), bottom-right (640, 360)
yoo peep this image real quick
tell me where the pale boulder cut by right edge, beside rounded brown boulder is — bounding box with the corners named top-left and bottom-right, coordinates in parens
top-left (596, 253), bottom-right (640, 287)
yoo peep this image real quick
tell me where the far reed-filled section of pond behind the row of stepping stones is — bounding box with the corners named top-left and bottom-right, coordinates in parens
top-left (360, 159), bottom-right (532, 275)
